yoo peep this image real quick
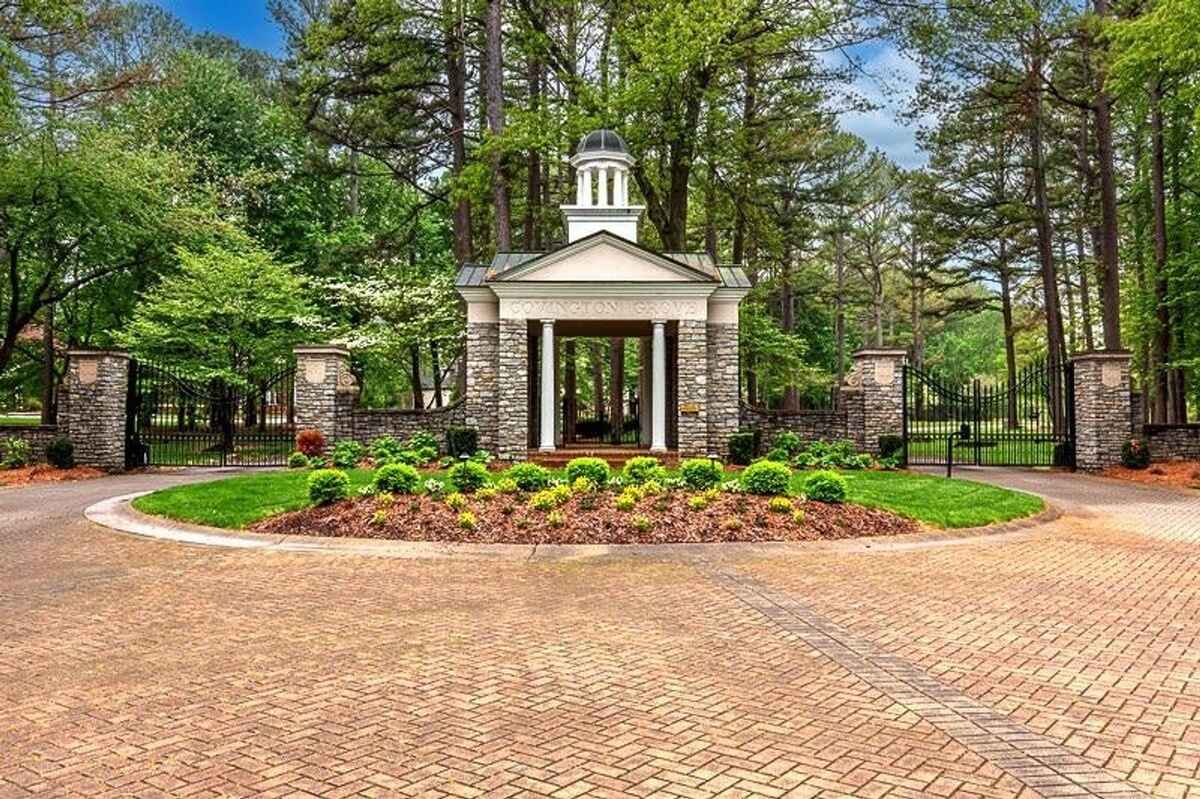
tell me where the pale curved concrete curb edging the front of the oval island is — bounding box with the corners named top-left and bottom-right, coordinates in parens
top-left (84, 491), bottom-right (1062, 561)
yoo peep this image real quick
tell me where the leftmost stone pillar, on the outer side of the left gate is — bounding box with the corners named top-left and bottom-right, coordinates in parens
top-left (60, 350), bottom-right (130, 471)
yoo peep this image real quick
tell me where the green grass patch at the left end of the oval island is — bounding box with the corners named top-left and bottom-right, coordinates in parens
top-left (133, 469), bottom-right (373, 528)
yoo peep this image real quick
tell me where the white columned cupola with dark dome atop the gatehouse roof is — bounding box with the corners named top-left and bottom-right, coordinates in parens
top-left (562, 130), bottom-right (646, 244)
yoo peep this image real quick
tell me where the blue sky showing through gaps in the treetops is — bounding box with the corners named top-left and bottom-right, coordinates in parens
top-left (156, 0), bottom-right (925, 168)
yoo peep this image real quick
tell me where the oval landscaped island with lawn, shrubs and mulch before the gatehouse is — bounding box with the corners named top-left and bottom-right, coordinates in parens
top-left (134, 429), bottom-right (1043, 543)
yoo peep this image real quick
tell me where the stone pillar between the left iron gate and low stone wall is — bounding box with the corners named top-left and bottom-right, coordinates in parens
top-left (293, 344), bottom-right (358, 446)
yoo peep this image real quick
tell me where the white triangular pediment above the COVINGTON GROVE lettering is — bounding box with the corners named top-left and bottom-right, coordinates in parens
top-left (499, 234), bottom-right (715, 283)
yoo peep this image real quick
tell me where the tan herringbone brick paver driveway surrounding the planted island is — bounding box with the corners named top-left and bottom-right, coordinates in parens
top-left (0, 473), bottom-right (1200, 798)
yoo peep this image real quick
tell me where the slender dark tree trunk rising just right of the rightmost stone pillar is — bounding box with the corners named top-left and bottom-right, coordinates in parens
top-left (1150, 79), bottom-right (1172, 425)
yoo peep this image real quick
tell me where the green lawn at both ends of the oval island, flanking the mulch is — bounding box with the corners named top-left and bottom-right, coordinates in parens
top-left (133, 460), bottom-right (1043, 528)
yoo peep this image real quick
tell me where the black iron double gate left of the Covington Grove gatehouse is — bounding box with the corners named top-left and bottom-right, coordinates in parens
top-left (125, 361), bottom-right (295, 468)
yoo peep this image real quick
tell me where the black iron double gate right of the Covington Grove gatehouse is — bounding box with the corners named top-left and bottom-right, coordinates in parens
top-left (904, 364), bottom-right (1075, 468)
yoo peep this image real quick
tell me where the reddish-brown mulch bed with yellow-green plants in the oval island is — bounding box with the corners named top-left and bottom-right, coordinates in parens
top-left (252, 492), bottom-right (920, 543)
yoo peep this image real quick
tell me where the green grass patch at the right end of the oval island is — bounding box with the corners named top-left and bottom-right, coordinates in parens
top-left (820, 471), bottom-right (1045, 528)
